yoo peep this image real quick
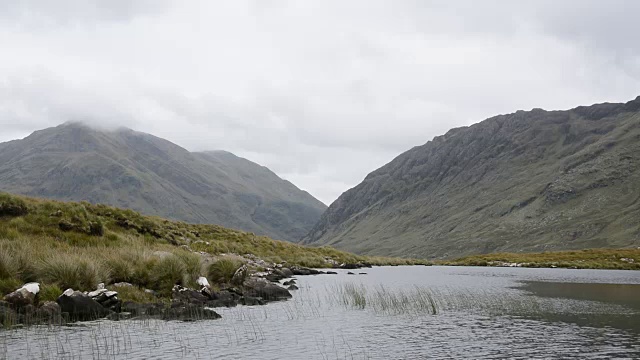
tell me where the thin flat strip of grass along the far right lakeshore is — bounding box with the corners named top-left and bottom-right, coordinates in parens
top-left (439, 249), bottom-right (640, 270)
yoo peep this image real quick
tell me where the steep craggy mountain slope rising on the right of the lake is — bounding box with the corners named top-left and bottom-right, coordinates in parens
top-left (302, 97), bottom-right (640, 258)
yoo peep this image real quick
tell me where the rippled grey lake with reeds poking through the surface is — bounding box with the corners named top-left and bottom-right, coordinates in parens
top-left (0, 266), bottom-right (640, 360)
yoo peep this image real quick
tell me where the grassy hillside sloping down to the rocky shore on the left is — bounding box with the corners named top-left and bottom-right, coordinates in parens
top-left (0, 193), bottom-right (428, 300)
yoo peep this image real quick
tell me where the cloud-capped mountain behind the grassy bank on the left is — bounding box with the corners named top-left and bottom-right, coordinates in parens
top-left (0, 123), bottom-right (326, 241)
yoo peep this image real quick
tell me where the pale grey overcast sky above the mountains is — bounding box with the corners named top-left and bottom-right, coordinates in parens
top-left (0, 0), bottom-right (640, 204)
